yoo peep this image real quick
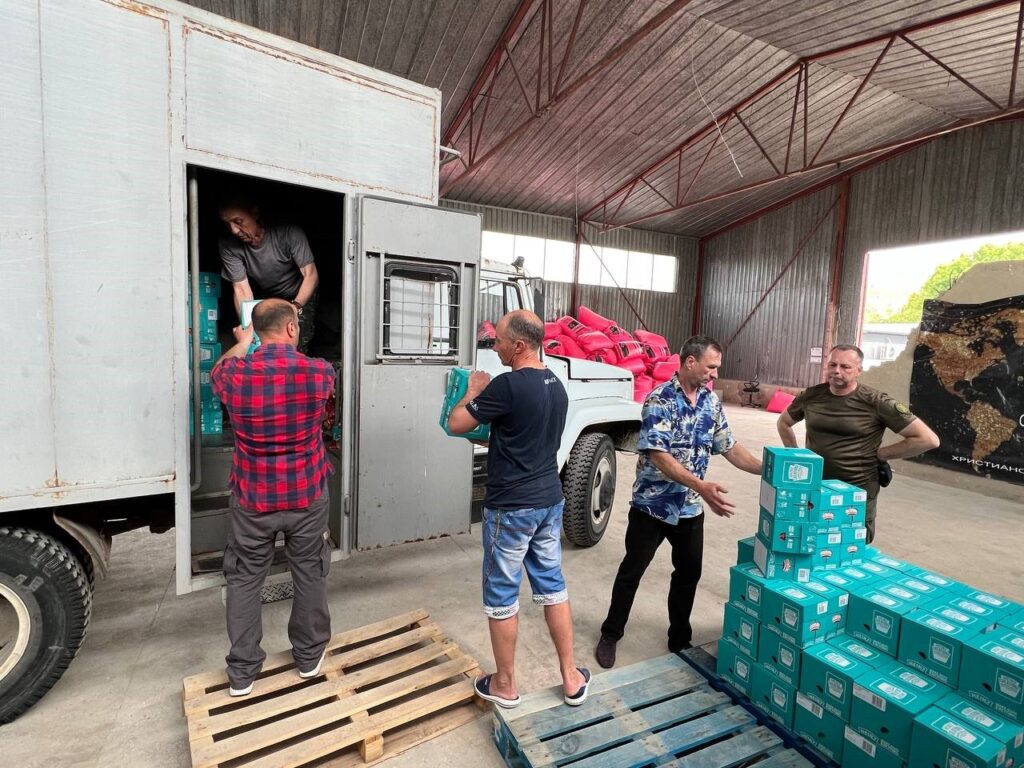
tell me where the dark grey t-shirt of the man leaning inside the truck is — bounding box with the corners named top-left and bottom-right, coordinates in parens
top-left (219, 224), bottom-right (313, 301)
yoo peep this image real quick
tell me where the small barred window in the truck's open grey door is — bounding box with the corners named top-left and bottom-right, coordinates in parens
top-left (381, 262), bottom-right (461, 357)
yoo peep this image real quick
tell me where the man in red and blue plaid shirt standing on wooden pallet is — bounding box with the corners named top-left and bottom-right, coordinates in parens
top-left (210, 299), bottom-right (335, 696)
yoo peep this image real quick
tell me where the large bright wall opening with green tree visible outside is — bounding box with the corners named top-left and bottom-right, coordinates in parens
top-left (860, 231), bottom-right (1024, 370)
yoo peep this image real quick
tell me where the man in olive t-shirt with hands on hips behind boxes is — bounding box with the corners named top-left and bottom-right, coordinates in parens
top-left (778, 344), bottom-right (939, 543)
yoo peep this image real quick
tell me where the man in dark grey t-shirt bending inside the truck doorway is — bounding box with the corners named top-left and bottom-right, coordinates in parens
top-left (219, 197), bottom-right (319, 352)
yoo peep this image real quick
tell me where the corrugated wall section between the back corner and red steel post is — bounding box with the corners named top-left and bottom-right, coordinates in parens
top-left (700, 187), bottom-right (838, 386)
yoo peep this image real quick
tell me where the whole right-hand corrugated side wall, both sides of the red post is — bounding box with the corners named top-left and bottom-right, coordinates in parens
top-left (700, 120), bottom-right (1024, 386)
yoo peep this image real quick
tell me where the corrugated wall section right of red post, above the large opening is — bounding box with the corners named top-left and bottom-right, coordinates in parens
top-left (837, 120), bottom-right (1024, 339)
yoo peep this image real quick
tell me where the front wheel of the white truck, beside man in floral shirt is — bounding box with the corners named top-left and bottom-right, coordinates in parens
top-left (562, 432), bottom-right (615, 547)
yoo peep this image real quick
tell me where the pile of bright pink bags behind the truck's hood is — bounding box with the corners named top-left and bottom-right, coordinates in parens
top-left (544, 306), bottom-right (679, 402)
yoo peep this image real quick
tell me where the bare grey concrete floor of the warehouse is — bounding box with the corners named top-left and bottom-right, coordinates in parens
top-left (0, 407), bottom-right (1024, 768)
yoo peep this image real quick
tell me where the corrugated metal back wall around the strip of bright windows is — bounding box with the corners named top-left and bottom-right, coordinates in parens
top-left (441, 200), bottom-right (697, 354)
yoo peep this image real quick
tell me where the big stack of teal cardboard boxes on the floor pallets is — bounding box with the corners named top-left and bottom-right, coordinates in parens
top-left (718, 447), bottom-right (1024, 768)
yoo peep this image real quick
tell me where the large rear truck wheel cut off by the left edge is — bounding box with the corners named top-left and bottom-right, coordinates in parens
top-left (0, 527), bottom-right (92, 724)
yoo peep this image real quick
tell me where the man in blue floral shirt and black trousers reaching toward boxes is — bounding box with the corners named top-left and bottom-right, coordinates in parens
top-left (594, 336), bottom-right (761, 669)
